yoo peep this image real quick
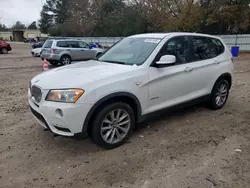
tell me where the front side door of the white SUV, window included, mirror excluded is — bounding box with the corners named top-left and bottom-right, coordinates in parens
top-left (148, 36), bottom-right (202, 113)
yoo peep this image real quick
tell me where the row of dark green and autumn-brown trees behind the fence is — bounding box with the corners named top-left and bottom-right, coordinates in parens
top-left (0, 0), bottom-right (250, 37)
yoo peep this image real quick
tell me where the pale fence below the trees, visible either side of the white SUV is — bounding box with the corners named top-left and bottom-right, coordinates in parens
top-left (49, 34), bottom-right (250, 52)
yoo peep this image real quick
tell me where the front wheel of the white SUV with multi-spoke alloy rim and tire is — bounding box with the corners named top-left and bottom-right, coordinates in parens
top-left (90, 102), bottom-right (135, 149)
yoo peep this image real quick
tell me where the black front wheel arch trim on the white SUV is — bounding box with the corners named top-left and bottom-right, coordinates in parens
top-left (83, 92), bottom-right (141, 133)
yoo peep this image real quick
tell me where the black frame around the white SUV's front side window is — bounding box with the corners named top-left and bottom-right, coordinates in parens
top-left (149, 35), bottom-right (192, 68)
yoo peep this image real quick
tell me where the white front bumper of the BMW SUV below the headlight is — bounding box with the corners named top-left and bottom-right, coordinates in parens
top-left (28, 91), bottom-right (92, 136)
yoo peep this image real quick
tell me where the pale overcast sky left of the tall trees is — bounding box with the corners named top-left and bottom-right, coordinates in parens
top-left (0, 0), bottom-right (45, 27)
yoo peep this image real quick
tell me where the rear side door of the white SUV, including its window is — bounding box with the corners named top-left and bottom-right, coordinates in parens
top-left (190, 36), bottom-right (224, 95)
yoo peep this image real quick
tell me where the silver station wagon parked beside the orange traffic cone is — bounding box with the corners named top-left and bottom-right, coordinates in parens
top-left (41, 39), bottom-right (104, 66)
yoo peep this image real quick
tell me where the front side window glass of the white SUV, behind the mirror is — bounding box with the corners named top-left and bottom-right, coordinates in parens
top-left (156, 37), bottom-right (189, 64)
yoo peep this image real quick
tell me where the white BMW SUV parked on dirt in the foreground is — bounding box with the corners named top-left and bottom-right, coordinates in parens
top-left (28, 33), bottom-right (234, 149)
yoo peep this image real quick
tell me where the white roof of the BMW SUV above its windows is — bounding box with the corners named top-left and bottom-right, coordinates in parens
top-left (130, 32), bottom-right (221, 39)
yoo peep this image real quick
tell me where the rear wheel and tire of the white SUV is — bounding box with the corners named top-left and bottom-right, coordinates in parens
top-left (210, 79), bottom-right (229, 110)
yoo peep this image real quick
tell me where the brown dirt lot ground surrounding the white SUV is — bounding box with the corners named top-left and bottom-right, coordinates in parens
top-left (0, 44), bottom-right (250, 188)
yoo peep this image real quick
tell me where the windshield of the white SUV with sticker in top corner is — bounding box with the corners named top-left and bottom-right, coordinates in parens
top-left (98, 38), bottom-right (161, 65)
